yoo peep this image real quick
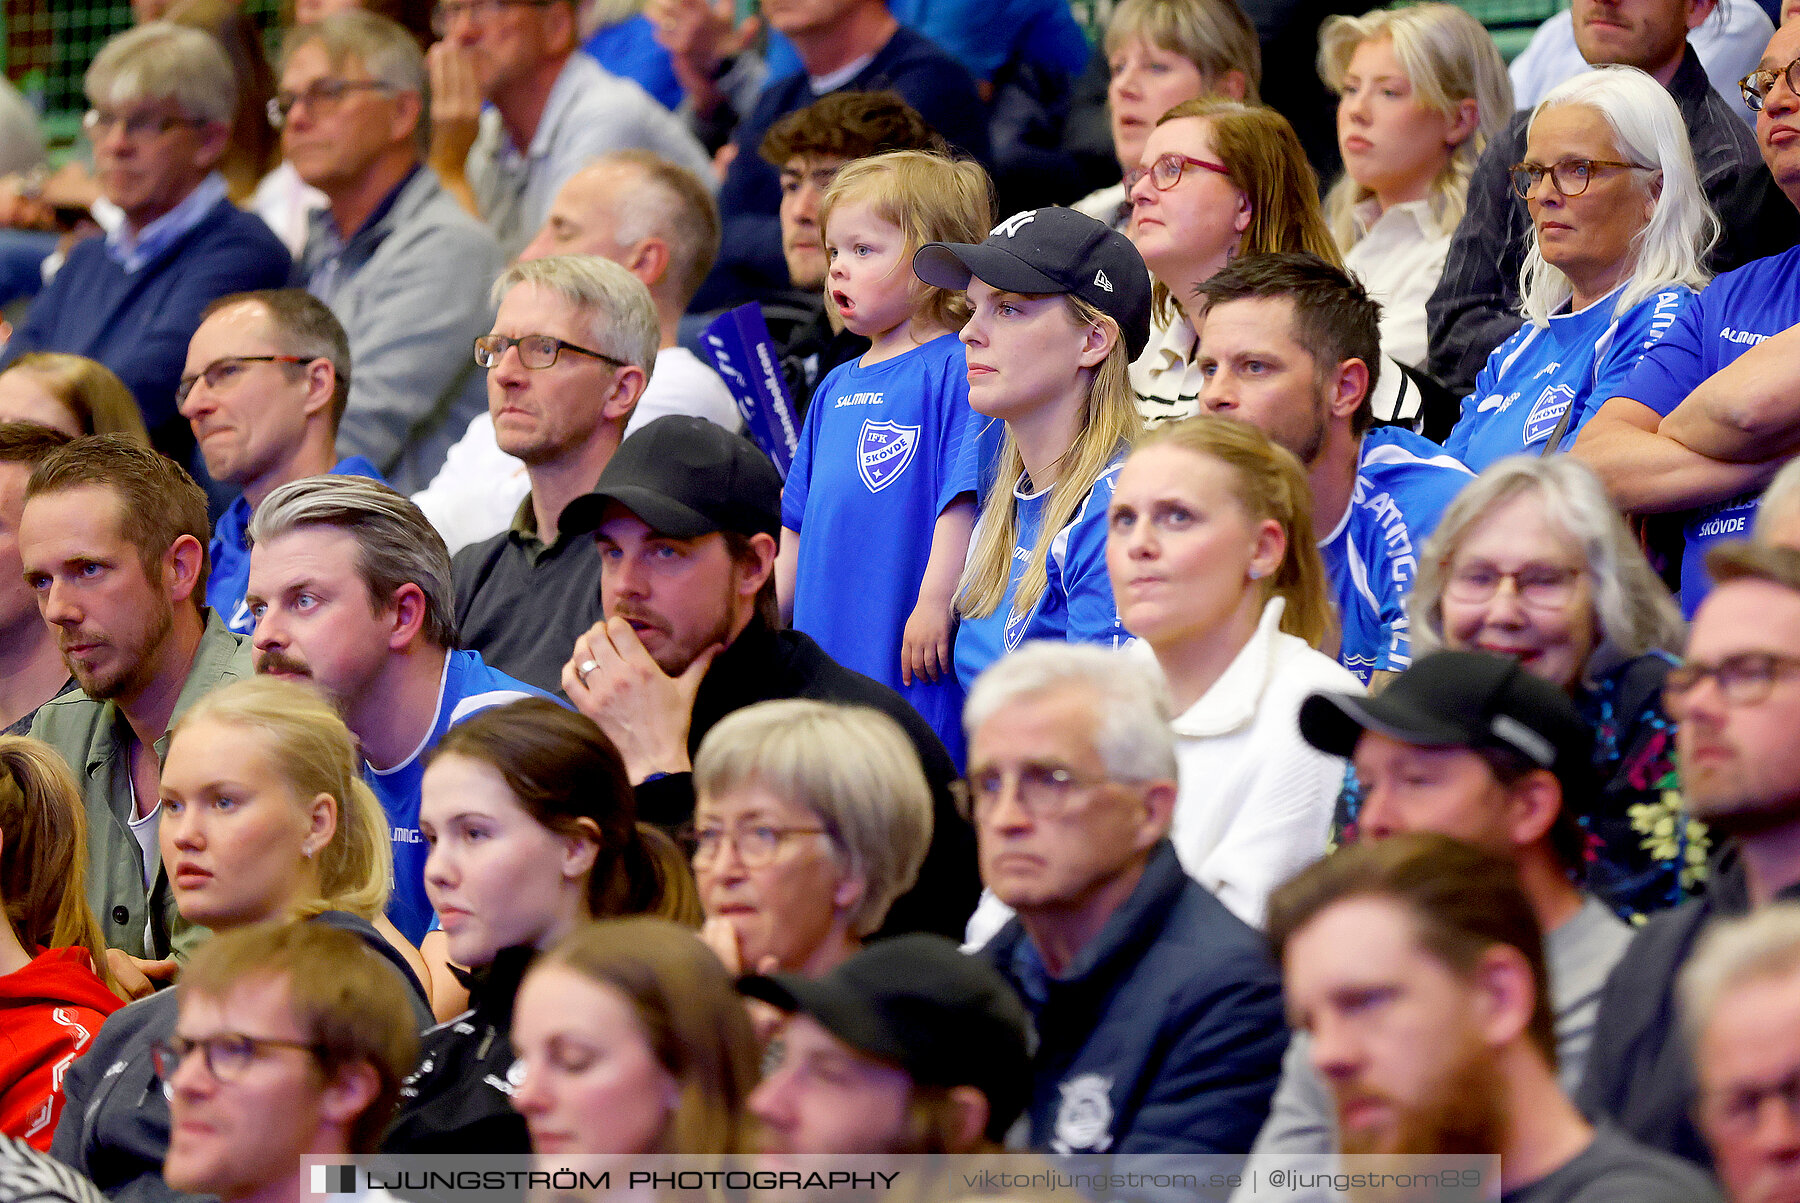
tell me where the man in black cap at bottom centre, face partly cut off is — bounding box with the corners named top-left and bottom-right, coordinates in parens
top-left (738, 935), bottom-right (1031, 1162)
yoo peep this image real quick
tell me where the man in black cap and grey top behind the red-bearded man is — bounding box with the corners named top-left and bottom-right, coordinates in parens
top-left (1246, 652), bottom-right (1631, 1198)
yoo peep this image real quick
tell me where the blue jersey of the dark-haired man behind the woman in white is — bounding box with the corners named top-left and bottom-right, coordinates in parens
top-left (1319, 427), bottom-right (1472, 684)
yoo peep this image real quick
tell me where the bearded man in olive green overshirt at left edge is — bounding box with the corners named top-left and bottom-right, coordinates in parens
top-left (18, 434), bottom-right (250, 994)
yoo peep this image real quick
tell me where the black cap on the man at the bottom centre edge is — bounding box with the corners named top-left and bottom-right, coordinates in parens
top-left (738, 933), bottom-right (1031, 1140)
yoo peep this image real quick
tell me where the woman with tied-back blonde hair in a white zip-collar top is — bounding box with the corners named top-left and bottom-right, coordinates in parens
top-left (1107, 418), bottom-right (1361, 926)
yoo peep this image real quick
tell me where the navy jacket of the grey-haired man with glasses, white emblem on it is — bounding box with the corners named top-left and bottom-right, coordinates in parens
top-left (983, 839), bottom-right (1287, 1153)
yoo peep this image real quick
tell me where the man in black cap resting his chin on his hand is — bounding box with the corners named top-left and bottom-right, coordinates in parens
top-left (562, 414), bottom-right (977, 935)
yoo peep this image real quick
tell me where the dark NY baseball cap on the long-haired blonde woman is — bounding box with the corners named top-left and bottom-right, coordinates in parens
top-left (913, 207), bottom-right (1150, 358)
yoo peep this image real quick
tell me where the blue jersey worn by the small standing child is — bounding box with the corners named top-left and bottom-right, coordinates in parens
top-left (781, 333), bottom-right (1001, 764)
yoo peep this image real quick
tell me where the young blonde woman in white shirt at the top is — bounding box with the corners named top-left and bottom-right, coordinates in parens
top-left (1319, 4), bottom-right (1512, 367)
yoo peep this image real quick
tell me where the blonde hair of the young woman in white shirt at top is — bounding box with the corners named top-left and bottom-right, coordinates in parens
top-left (1319, 4), bottom-right (1512, 250)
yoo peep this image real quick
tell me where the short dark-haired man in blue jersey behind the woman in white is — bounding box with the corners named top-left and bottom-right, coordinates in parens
top-left (1195, 254), bottom-right (1471, 683)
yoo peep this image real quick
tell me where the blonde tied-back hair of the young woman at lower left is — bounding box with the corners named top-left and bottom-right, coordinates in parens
top-left (171, 677), bottom-right (394, 922)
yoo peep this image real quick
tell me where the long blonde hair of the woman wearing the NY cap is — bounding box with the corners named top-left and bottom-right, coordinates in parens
top-left (956, 295), bottom-right (1143, 618)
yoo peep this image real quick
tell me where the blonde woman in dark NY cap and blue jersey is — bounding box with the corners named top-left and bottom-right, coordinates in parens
top-left (913, 209), bottom-right (1150, 688)
